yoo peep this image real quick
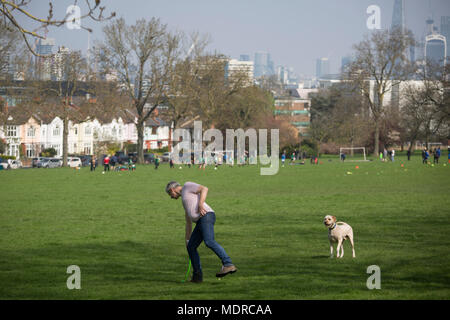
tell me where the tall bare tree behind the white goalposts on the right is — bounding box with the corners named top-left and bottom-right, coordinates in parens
top-left (344, 28), bottom-right (414, 155)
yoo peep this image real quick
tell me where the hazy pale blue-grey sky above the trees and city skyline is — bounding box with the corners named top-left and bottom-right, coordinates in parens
top-left (19, 0), bottom-right (450, 75)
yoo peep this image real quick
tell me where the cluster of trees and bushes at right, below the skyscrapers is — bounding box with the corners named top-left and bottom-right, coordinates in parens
top-left (310, 28), bottom-right (450, 155)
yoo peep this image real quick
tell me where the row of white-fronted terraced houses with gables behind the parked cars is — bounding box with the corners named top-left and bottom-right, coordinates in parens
top-left (0, 108), bottom-right (172, 158)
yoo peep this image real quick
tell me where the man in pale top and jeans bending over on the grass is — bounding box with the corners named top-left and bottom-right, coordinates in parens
top-left (166, 181), bottom-right (237, 283)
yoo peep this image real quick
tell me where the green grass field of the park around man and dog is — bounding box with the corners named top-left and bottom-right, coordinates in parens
top-left (0, 155), bottom-right (450, 299)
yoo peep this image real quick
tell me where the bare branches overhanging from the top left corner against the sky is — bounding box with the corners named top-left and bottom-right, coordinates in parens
top-left (0, 0), bottom-right (115, 56)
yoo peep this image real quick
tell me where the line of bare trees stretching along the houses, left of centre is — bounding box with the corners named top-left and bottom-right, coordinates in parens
top-left (0, 14), bottom-right (278, 165)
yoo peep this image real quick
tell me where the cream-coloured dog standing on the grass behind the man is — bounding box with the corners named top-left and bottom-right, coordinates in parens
top-left (323, 215), bottom-right (355, 258)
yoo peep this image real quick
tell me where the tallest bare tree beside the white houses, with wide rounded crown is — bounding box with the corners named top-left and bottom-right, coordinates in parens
top-left (97, 18), bottom-right (180, 163)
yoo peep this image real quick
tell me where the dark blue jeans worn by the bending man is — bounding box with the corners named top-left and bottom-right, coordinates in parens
top-left (187, 211), bottom-right (232, 273)
